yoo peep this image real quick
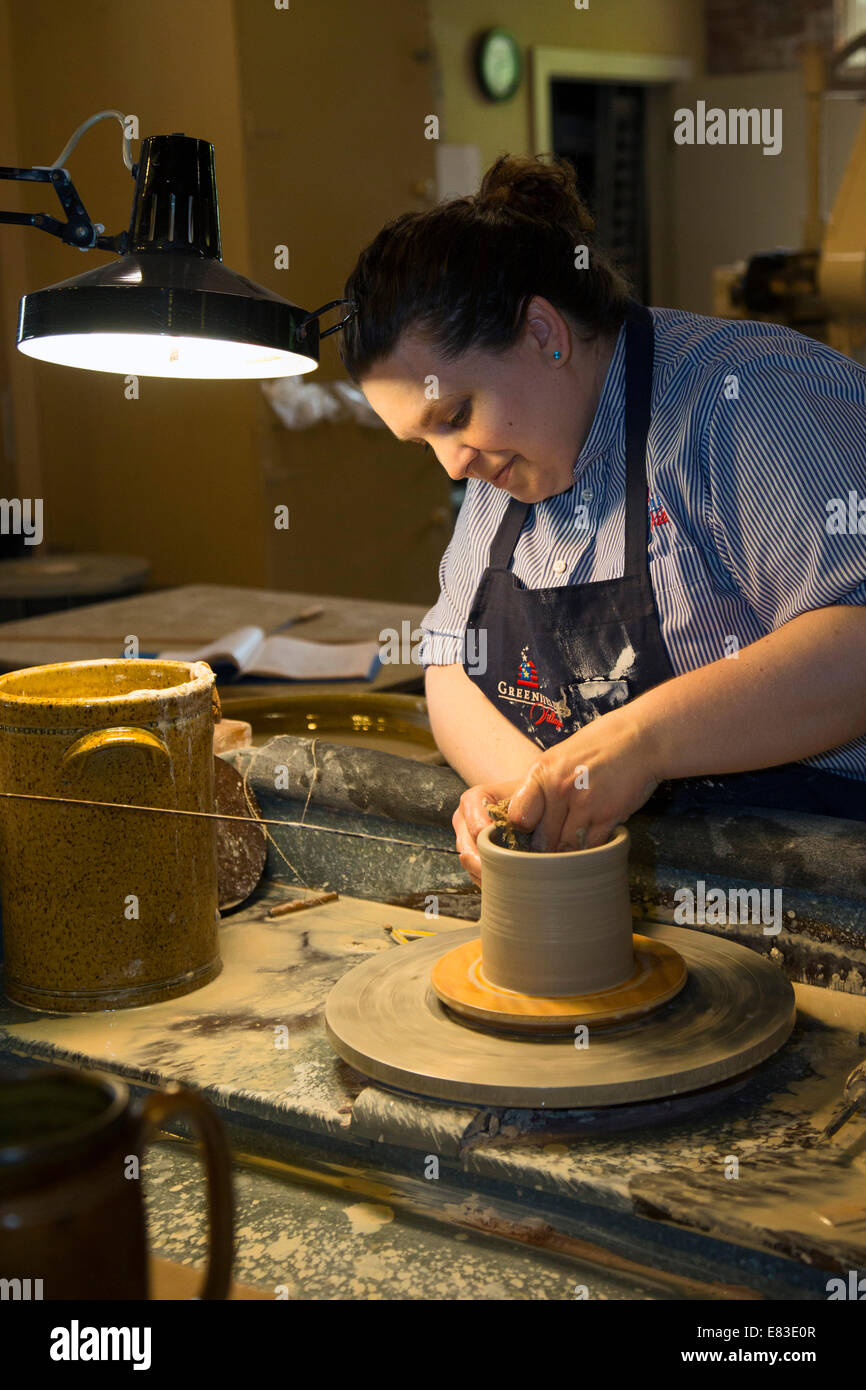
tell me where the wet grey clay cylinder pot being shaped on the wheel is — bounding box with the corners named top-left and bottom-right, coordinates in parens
top-left (477, 826), bottom-right (634, 998)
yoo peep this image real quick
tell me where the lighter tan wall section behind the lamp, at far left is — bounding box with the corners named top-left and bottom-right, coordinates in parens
top-left (0, 0), bottom-right (265, 584)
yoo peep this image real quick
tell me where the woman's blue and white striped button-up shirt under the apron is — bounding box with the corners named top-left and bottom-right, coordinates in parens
top-left (420, 309), bottom-right (866, 780)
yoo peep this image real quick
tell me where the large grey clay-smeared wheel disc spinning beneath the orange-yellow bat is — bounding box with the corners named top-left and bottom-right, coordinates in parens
top-left (325, 923), bottom-right (795, 1109)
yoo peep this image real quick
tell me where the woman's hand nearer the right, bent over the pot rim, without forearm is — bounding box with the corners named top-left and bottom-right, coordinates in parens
top-left (509, 705), bottom-right (664, 851)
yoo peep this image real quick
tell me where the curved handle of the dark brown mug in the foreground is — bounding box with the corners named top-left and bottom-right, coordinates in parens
top-left (139, 1081), bottom-right (234, 1298)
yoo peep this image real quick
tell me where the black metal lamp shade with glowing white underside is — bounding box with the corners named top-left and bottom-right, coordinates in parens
top-left (18, 135), bottom-right (318, 378)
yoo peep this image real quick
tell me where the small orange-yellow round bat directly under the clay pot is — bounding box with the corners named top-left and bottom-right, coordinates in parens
top-left (430, 935), bottom-right (687, 1037)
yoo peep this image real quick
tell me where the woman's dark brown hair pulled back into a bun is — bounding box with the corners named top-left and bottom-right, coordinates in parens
top-left (339, 154), bottom-right (630, 382)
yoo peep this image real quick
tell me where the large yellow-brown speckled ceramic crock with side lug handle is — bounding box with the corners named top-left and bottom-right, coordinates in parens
top-left (0, 659), bottom-right (221, 1013)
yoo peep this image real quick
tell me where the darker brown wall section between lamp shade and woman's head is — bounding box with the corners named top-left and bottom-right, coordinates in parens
top-left (230, 0), bottom-right (452, 603)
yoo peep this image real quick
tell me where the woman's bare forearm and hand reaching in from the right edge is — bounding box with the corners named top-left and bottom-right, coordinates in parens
top-left (452, 605), bottom-right (866, 883)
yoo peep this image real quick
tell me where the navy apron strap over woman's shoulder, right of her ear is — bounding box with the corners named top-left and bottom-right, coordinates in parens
top-left (623, 299), bottom-right (653, 577)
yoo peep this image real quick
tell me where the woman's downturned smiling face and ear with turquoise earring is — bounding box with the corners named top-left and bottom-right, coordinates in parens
top-left (361, 296), bottom-right (616, 502)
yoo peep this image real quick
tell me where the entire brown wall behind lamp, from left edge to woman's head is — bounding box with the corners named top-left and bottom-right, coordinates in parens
top-left (0, 0), bottom-right (450, 602)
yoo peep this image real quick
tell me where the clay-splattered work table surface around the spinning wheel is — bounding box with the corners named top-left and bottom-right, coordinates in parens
top-left (0, 881), bottom-right (866, 1298)
